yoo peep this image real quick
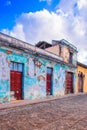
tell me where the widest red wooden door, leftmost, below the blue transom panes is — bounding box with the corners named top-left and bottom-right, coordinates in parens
top-left (10, 71), bottom-right (22, 100)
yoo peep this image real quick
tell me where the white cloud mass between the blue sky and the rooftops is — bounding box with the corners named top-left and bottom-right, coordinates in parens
top-left (2, 0), bottom-right (87, 64)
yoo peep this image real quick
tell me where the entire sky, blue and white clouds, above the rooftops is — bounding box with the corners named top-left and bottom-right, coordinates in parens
top-left (0, 0), bottom-right (87, 65)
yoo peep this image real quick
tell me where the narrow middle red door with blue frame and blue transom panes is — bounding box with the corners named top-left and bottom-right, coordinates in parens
top-left (46, 68), bottom-right (52, 95)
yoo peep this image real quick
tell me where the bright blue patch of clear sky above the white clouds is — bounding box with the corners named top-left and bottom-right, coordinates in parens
top-left (0, 0), bottom-right (59, 29)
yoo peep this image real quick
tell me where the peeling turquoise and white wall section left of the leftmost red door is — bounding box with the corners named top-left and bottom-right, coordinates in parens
top-left (0, 50), bottom-right (10, 102)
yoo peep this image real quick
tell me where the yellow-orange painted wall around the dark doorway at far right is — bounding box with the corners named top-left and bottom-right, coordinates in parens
top-left (76, 65), bottom-right (87, 93)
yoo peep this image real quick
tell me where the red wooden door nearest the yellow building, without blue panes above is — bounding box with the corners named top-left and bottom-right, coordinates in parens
top-left (66, 72), bottom-right (73, 93)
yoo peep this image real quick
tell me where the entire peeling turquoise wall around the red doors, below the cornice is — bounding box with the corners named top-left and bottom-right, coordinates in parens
top-left (0, 49), bottom-right (76, 102)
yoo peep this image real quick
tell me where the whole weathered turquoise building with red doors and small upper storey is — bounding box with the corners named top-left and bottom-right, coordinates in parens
top-left (0, 33), bottom-right (77, 103)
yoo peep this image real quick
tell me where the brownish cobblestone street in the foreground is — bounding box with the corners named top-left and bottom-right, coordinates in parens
top-left (0, 94), bottom-right (87, 130)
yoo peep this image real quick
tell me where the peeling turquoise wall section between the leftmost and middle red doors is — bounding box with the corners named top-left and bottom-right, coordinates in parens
top-left (24, 56), bottom-right (46, 99)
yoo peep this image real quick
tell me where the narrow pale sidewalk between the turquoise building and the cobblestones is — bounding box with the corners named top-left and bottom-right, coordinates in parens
top-left (0, 93), bottom-right (87, 110)
